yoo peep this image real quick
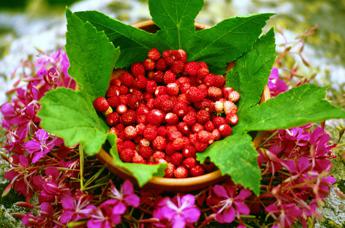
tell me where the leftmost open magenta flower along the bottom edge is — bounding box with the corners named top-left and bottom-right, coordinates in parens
top-left (60, 192), bottom-right (95, 224)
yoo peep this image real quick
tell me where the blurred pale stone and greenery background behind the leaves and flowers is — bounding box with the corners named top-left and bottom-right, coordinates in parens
top-left (0, 0), bottom-right (345, 227)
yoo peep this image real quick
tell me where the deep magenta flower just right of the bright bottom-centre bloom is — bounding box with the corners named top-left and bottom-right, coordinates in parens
top-left (207, 183), bottom-right (251, 223)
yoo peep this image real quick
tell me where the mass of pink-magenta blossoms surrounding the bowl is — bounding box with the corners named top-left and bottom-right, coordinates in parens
top-left (1, 50), bottom-right (335, 228)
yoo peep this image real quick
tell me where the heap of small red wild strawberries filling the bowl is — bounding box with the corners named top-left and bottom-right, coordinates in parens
top-left (93, 48), bottom-right (240, 178)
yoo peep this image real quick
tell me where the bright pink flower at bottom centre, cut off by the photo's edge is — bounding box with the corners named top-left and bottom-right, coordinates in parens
top-left (153, 194), bottom-right (201, 228)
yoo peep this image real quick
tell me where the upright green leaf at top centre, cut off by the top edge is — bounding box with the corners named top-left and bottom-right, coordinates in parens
top-left (149, 0), bottom-right (203, 49)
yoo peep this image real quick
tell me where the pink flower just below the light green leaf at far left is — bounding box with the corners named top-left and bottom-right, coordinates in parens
top-left (24, 129), bottom-right (62, 163)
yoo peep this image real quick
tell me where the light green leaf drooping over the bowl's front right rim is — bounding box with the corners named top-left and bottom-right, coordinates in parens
top-left (197, 134), bottom-right (261, 195)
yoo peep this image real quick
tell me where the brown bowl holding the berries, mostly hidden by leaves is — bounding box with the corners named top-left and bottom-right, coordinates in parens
top-left (97, 20), bottom-right (270, 192)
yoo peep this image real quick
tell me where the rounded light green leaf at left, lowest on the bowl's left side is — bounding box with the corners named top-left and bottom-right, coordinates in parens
top-left (38, 88), bottom-right (108, 155)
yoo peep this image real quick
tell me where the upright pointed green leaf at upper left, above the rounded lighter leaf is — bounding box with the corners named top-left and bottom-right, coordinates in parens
top-left (66, 10), bottom-right (120, 100)
